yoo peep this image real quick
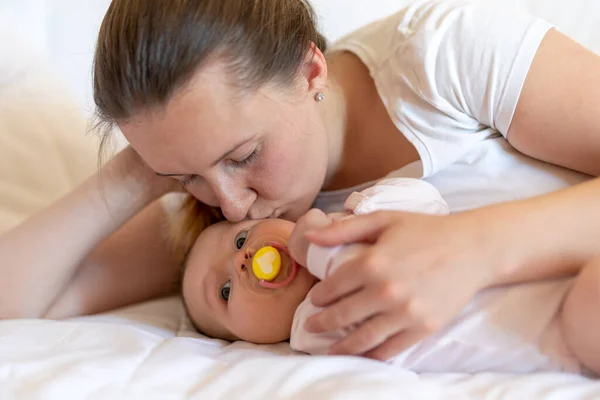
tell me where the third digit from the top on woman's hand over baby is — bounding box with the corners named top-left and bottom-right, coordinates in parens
top-left (305, 287), bottom-right (386, 333)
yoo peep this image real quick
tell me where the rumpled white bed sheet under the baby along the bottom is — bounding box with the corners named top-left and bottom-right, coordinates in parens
top-left (0, 297), bottom-right (600, 400)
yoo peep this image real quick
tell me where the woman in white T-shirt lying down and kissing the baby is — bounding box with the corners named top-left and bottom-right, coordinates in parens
top-left (0, 0), bottom-right (600, 368)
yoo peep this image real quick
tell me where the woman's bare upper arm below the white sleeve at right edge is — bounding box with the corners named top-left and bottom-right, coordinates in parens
top-left (507, 29), bottom-right (600, 176)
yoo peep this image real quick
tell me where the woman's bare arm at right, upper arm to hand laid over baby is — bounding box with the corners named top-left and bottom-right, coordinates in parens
top-left (292, 26), bottom-right (600, 360)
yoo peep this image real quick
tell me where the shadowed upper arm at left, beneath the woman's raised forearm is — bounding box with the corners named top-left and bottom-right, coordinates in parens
top-left (44, 201), bottom-right (180, 319)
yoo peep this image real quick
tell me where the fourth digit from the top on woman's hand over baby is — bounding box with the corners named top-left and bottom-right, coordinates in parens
top-left (329, 314), bottom-right (408, 355)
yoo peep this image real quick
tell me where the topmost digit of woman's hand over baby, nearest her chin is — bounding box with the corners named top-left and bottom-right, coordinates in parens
top-left (306, 211), bottom-right (392, 246)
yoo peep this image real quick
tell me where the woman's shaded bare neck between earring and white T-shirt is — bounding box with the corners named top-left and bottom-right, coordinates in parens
top-left (323, 52), bottom-right (419, 190)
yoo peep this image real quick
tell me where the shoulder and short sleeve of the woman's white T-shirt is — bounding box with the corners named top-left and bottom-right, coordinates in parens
top-left (331, 0), bottom-right (551, 176)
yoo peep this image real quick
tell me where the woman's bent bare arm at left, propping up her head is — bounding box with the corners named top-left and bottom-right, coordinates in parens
top-left (0, 148), bottom-right (180, 319)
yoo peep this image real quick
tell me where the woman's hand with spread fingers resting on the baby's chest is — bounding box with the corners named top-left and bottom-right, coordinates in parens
top-left (307, 211), bottom-right (506, 360)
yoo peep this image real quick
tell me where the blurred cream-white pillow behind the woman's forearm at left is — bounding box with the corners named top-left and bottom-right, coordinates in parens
top-left (0, 24), bottom-right (98, 233)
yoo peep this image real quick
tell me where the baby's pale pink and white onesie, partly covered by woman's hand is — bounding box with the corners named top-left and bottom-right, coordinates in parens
top-left (290, 178), bottom-right (582, 373)
